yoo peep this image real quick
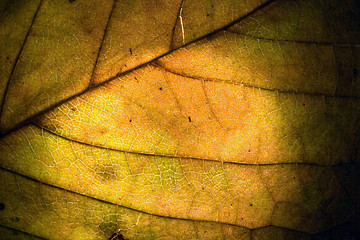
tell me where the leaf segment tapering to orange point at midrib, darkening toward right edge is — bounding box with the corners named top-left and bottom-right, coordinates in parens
top-left (157, 31), bottom-right (360, 97)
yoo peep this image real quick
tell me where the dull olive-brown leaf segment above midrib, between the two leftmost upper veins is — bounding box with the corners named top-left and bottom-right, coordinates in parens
top-left (1, 0), bottom-right (111, 131)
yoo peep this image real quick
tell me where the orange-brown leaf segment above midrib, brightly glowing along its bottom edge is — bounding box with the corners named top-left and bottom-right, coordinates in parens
top-left (89, 0), bottom-right (181, 85)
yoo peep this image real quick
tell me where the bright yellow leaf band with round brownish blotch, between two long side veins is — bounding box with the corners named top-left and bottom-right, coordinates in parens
top-left (1, 127), bottom-right (274, 228)
